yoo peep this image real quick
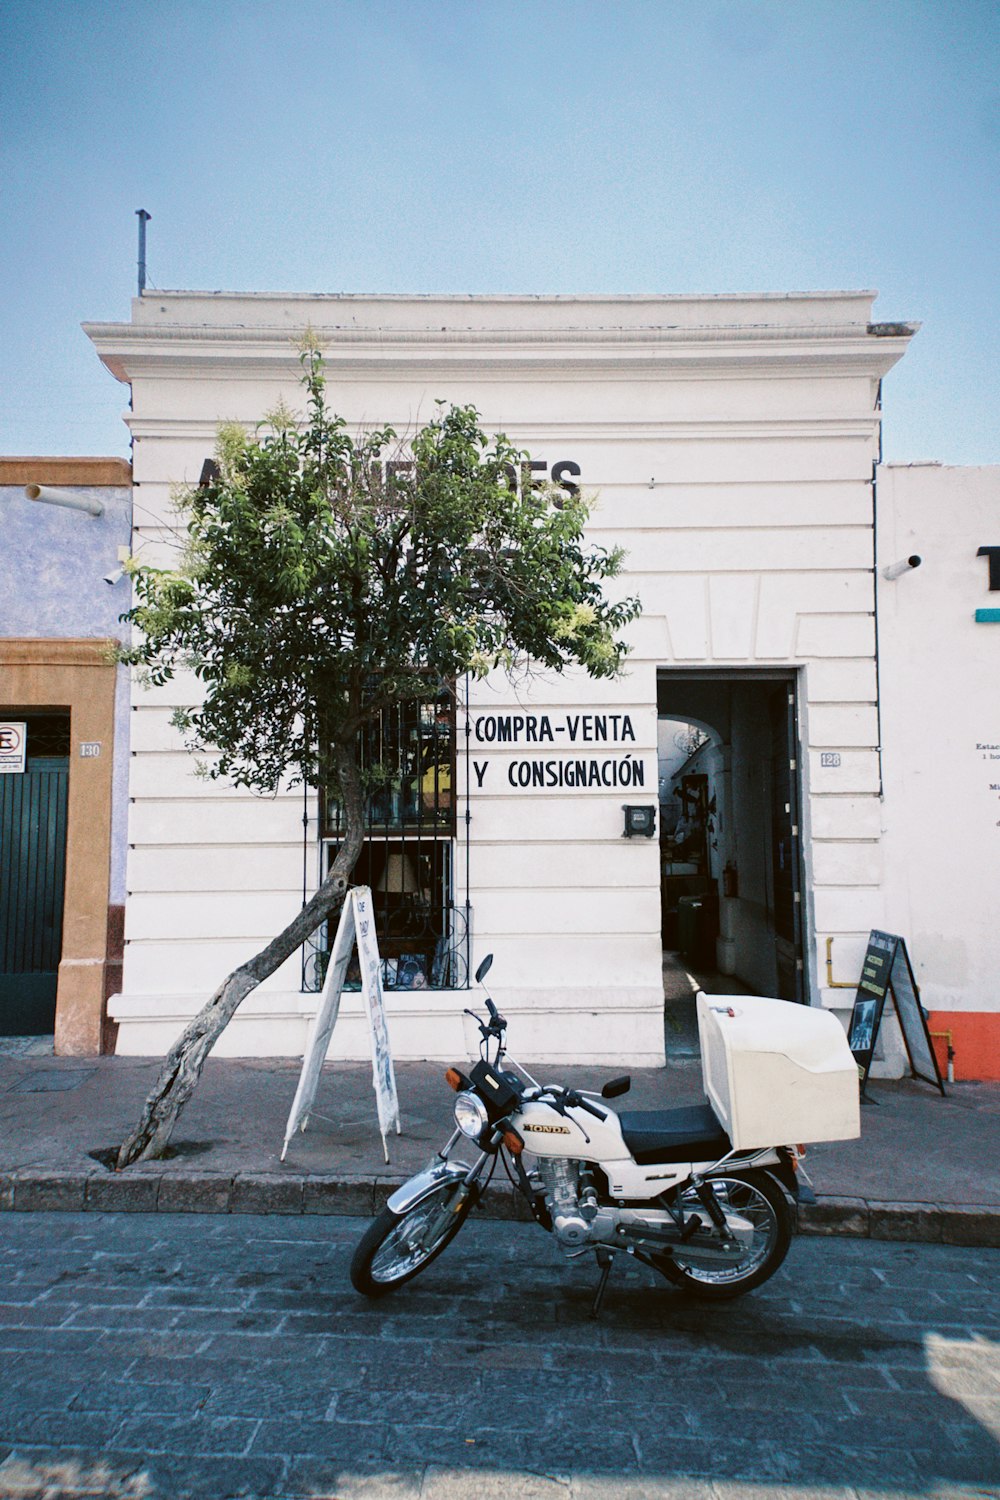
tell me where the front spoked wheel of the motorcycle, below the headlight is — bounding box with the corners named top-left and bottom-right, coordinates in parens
top-left (351, 1179), bottom-right (475, 1298)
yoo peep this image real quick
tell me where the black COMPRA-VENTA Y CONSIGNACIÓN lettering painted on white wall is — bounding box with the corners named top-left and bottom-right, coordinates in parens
top-left (469, 710), bottom-right (655, 792)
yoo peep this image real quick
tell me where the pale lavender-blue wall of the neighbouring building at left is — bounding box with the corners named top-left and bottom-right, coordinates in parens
top-left (0, 485), bottom-right (132, 905)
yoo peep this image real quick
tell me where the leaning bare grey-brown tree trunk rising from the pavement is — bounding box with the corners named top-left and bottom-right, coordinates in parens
top-left (115, 746), bottom-right (364, 1172)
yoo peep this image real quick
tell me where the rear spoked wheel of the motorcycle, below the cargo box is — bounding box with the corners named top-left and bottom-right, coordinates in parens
top-left (658, 1172), bottom-right (792, 1301)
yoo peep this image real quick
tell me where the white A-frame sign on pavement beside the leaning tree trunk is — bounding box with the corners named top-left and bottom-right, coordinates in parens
top-left (282, 885), bottom-right (402, 1161)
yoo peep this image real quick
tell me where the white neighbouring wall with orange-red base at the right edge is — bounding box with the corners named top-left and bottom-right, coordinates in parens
top-left (877, 464), bottom-right (1000, 1080)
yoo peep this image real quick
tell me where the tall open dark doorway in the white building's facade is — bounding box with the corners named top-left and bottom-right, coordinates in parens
top-left (657, 669), bottom-right (805, 1052)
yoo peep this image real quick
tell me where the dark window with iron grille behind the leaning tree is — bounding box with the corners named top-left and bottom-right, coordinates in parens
top-left (303, 692), bottom-right (469, 990)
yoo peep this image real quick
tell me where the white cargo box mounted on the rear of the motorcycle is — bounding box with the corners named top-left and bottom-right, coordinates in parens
top-left (697, 993), bottom-right (861, 1151)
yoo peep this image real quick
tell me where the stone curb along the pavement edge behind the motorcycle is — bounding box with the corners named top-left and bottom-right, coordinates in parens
top-left (0, 1167), bottom-right (1000, 1248)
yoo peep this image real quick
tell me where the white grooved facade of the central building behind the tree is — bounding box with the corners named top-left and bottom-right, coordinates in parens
top-left (87, 293), bottom-right (941, 1071)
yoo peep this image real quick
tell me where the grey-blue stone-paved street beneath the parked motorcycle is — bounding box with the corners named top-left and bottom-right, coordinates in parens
top-left (0, 1212), bottom-right (1000, 1500)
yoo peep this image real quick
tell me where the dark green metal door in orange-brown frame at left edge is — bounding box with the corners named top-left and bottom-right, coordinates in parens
top-left (0, 714), bottom-right (69, 1037)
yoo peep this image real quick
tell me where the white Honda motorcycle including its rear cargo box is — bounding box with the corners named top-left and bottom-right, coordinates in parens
top-left (351, 956), bottom-right (861, 1317)
